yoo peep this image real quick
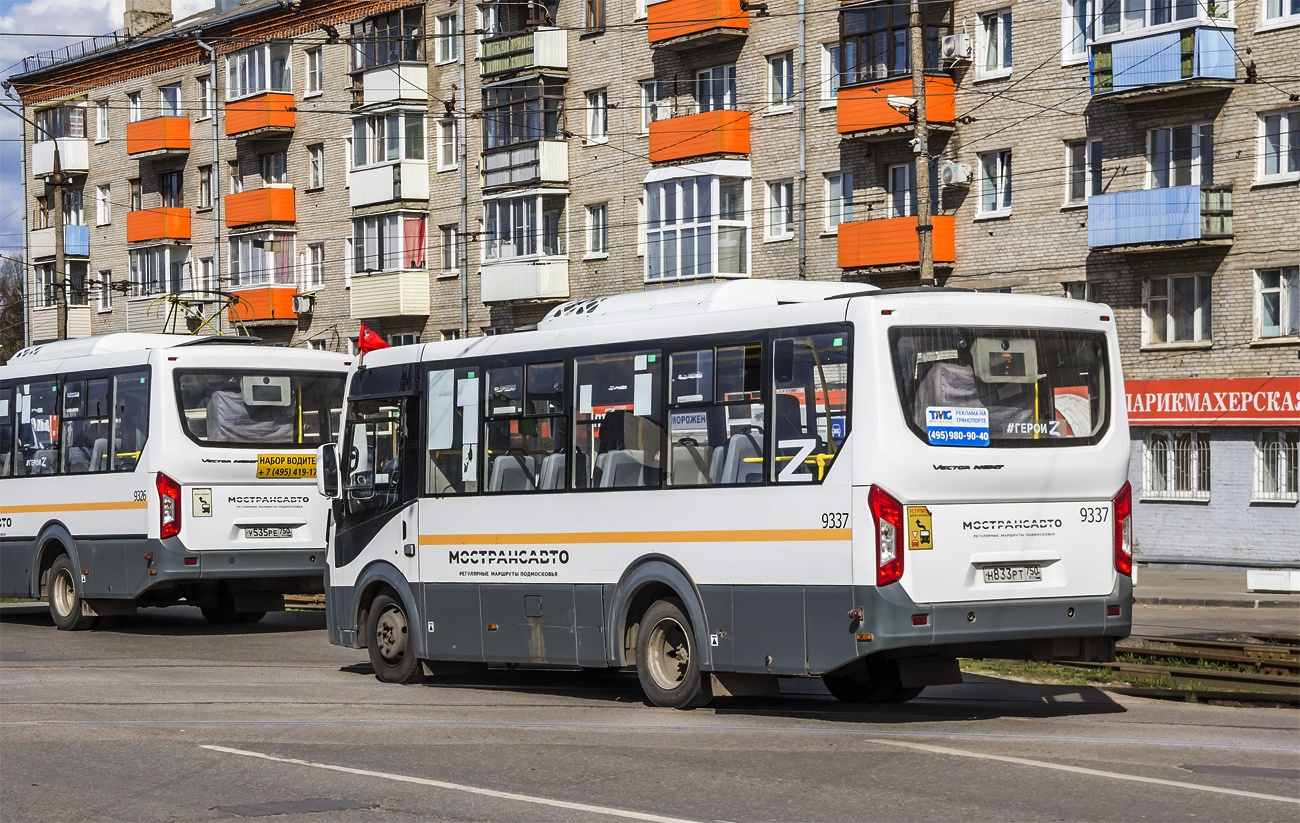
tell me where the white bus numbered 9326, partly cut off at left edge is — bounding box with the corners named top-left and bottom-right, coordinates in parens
top-left (0, 334), bottom-right (348, 629)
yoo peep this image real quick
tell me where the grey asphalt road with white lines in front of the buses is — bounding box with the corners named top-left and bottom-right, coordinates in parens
top-left (0, 608), bottom-right (1300, 823)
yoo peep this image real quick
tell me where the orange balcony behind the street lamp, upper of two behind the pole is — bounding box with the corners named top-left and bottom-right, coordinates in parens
top-left (836, 75), bottom-right (957, 140)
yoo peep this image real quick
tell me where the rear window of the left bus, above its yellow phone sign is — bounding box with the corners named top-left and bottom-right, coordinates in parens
top-left (177, 369), bottom-right (345, 449)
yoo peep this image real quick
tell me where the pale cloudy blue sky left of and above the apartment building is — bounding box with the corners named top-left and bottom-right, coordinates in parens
top-left (0, 0), bottom-right (212, 250)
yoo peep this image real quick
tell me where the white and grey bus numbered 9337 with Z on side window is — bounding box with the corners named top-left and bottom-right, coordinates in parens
top-left (319, 281), bottom-right (1132, 707)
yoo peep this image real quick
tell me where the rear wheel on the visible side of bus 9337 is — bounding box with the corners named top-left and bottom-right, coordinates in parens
top-left (637, 601), bottom-right (714, 709)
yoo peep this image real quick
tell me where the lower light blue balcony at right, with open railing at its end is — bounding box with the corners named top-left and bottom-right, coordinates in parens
top-left (1088, 186), bottom-right (1232, 252)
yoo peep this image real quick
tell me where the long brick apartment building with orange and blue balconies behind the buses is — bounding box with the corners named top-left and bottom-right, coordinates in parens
top-left (10, 0), bottom-right (1300, 563)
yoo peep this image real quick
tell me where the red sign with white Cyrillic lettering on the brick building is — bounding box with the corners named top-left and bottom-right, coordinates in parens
top-left (1125, 374), bottom-right (1300, 425)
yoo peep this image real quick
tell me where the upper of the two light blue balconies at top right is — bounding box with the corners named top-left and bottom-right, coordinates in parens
top-left (1088, 26), bottom-right (1238, 103)
